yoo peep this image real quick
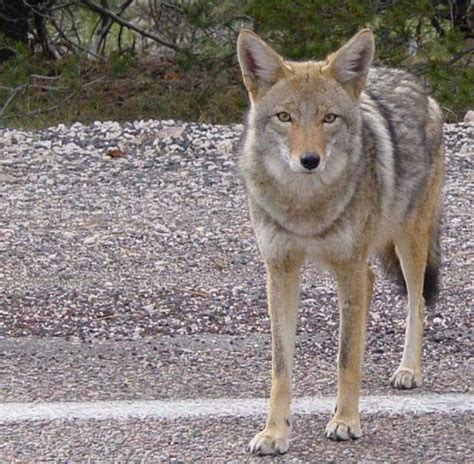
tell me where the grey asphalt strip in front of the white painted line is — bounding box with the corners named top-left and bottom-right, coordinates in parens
top-left (0, 415), bottom-right (473, 463)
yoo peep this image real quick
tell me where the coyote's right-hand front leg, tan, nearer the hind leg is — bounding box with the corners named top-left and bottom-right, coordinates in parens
top-left (326, 262), bottom-right (374, 441)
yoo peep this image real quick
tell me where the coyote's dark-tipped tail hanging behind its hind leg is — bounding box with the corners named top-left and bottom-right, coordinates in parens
top-left (379, 232), bottom-right (440, 305)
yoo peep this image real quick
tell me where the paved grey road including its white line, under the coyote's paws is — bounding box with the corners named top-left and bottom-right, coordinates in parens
top-left (0, 335), bottom-right (474, 463)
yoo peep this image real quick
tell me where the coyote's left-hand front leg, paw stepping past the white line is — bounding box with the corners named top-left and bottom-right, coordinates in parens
top-left (250, 258), bottom-right (301, 454)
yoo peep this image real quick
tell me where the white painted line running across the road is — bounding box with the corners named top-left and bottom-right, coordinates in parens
top-left (0, 393), bottom-right (474, 423)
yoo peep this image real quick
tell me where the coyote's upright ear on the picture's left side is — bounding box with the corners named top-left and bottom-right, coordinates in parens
top-left (237, 29), bottom-right (289, 100)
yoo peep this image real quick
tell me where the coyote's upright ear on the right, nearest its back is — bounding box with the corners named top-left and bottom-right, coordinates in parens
top-left (324, 29), bottom-right (375, 98)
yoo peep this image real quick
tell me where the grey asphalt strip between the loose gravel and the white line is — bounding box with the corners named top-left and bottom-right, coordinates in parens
top-left (0, 334), bottom-right (474, 402)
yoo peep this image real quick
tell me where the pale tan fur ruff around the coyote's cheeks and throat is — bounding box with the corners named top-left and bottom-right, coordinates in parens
top-left (240, 99), bottom-right (367, 238)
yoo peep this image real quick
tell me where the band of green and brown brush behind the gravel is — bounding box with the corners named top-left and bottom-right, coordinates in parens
top-left (0, 0), bottom-right (474, 127)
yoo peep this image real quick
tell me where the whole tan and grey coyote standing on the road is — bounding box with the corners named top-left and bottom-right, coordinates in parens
top-left (237, 29), bottom-right (444, 454)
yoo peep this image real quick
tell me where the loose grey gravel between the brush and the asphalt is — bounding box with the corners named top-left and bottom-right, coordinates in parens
top-left (0, 120), bottom-right (474, 360)
